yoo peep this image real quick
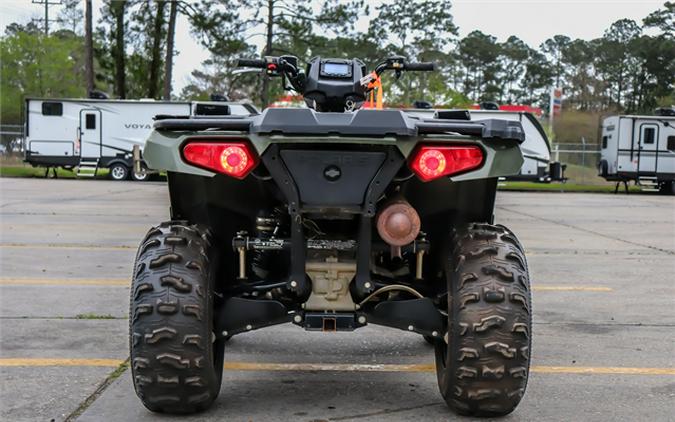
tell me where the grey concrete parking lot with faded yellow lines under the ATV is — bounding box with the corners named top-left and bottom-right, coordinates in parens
top-left (0, 179), bottom-right (675, 421)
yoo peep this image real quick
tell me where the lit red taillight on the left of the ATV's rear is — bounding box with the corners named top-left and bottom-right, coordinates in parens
top-left (183, 142), bottom-right (258, 179)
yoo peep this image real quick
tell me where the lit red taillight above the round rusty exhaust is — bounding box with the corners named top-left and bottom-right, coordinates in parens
top-left (410, 145), bottom-right (483, 182)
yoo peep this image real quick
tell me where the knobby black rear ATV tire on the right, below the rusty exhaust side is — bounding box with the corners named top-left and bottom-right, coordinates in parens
top-left (435, 223), bottom-right (532, 417)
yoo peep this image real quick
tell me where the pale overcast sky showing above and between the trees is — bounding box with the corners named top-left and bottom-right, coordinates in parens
top-left (0, 0), bottom-right (665, 93)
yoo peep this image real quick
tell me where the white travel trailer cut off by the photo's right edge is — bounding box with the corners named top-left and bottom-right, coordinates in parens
top-left (598, 115), bottom-right (675, 193)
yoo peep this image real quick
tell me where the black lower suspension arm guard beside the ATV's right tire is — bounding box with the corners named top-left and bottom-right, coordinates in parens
top-left (368, 298), bottom-right (446, 337)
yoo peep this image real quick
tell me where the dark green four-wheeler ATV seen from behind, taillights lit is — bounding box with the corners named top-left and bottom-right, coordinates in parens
top-left (129, 56), bottom-right (531, 416)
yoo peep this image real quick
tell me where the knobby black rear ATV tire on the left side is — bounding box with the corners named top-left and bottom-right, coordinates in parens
top-left (129, 222), bottom-right (224, 414)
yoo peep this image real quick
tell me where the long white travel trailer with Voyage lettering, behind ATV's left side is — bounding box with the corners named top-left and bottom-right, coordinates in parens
top-left (25, 98), bottom-right (258, 180)
